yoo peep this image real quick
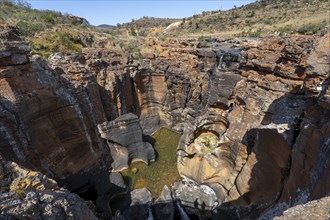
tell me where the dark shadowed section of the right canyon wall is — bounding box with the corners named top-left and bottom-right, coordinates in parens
top-left (212, 79), bottom-right (330, 220)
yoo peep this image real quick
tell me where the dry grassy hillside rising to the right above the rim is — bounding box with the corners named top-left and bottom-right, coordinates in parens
top-left (107, 0), bottom-right (330, 37)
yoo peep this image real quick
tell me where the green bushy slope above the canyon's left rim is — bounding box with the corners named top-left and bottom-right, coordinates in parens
top-left (0, 0), bottom-right (116, 57)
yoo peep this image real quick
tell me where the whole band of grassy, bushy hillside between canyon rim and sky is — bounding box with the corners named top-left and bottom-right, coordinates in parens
top-left (0, 0), bottom-right (330, 59)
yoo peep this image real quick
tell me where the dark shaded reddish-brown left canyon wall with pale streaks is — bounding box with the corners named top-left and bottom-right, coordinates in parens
top-left (0, 23), bottom-right (116, 215)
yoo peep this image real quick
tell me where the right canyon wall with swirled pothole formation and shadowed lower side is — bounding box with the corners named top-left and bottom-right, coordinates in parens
top-left (178, 33), bottom-right (330, 219)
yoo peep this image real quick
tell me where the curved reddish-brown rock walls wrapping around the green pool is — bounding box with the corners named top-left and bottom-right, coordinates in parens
top-left (0, 22), bottom-right (330, 218)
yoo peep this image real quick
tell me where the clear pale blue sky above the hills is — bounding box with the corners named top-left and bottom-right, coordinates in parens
top-left (27, 0), bottom-right (255, 25)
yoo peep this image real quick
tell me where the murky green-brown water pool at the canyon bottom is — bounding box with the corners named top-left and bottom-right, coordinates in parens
top-left (121, 128), bottom-right (180, 198)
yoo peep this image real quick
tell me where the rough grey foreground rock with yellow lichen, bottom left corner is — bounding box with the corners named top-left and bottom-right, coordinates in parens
top-left (0, 160), bottom-right (97, 220)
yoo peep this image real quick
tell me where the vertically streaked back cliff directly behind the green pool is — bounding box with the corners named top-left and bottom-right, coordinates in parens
top-left (78, 37), bottom-right (217, 134)
